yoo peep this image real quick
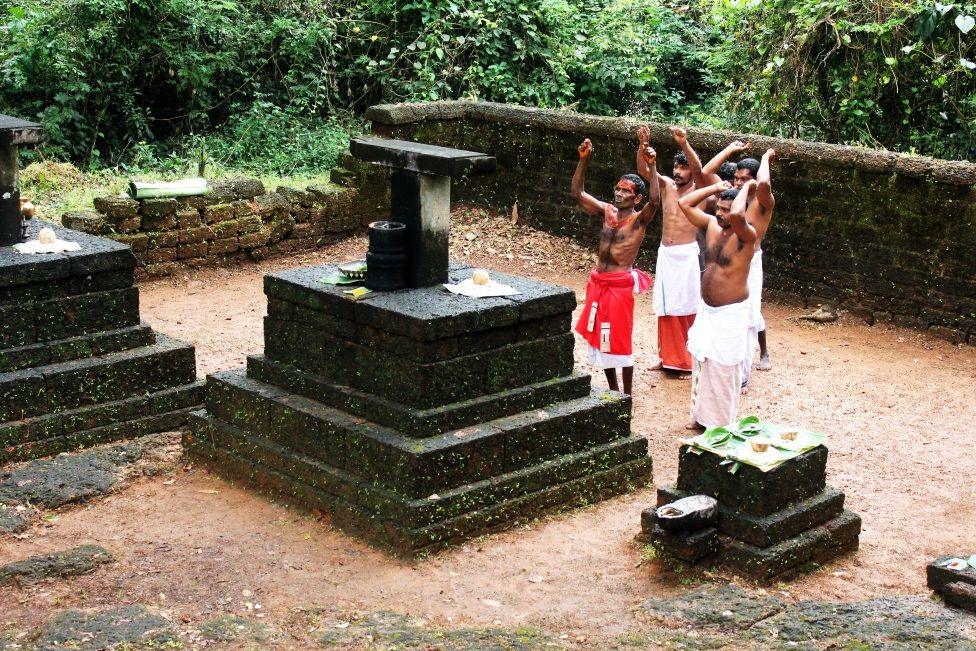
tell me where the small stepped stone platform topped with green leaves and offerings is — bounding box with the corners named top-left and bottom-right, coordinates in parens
top-left (641, 445), bottom-right (861, 582)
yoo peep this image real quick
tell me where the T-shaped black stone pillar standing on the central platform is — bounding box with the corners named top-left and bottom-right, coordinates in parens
top-left (349, 138), bottom-right (495, 287)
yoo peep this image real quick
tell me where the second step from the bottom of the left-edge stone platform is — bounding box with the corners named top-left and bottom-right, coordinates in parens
top-left (0, 334), bottom-right (196, 422)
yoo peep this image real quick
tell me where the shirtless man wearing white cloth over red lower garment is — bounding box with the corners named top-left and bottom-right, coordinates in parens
top-left (637, 126), bottom-right (701, 378)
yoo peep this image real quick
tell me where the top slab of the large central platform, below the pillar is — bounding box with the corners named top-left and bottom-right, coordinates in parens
top-left (264, 265), bottom-right (576, 341)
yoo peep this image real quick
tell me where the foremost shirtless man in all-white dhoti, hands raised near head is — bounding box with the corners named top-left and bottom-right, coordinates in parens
top-left (678, 181), bottom-right (756, 429)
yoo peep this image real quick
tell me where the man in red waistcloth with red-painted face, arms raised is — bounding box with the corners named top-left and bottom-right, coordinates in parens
top-left (573, 138), bottom-right (661, 394)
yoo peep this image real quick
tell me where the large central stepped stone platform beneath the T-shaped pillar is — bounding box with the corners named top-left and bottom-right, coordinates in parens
top-left (184, 265), bottom-right (651, 556)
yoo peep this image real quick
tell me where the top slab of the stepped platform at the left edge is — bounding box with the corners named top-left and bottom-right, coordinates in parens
top-left (0, 219), bottom-right (138, 287)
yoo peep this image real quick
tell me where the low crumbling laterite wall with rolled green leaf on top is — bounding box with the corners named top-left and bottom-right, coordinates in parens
top-left (61, 179), bottom-right (361, 278)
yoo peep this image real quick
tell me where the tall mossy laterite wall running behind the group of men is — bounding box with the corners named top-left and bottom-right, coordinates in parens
top-left (358, 102), bottom-right (976, 345)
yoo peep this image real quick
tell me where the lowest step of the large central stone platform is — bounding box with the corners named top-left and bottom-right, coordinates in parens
top-left (184, 411), bottom-right (651, 555)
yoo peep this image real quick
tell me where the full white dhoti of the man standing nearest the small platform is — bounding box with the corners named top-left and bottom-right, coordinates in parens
top-left (688, 299), bottom-right (750, 427)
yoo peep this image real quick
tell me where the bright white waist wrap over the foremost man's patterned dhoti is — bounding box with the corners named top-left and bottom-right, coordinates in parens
top-left (688, 299), bottom-right (751, 366)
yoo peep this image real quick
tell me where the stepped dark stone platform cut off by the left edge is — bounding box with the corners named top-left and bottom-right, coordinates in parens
top-left (0, 220), bottom-right (203, 464)
